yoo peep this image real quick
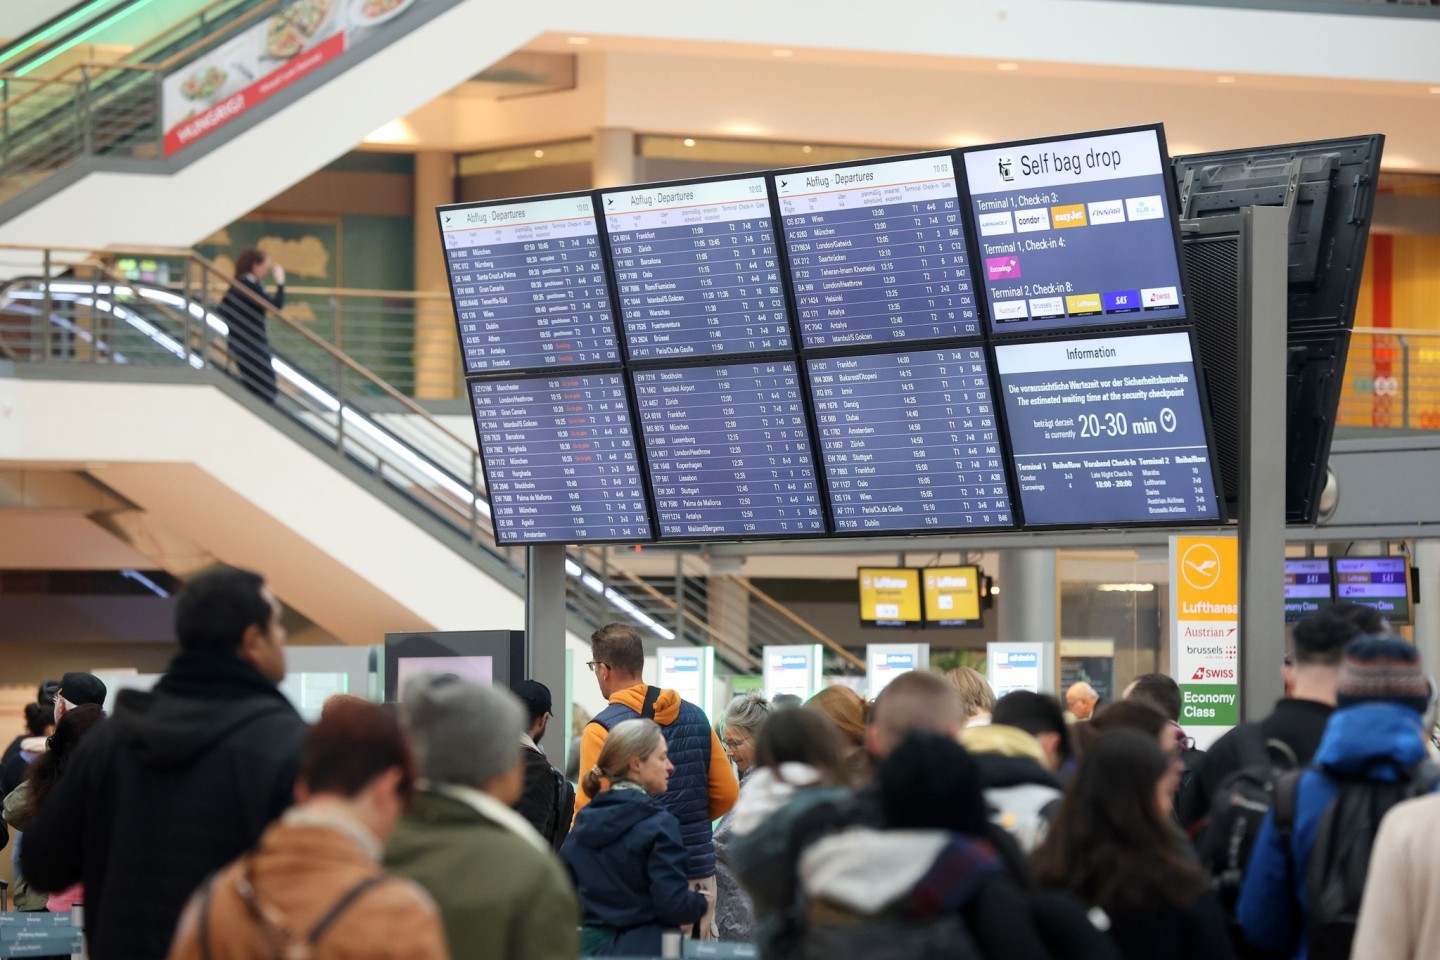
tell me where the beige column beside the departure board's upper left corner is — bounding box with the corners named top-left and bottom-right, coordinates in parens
top-left (412, 150), bottom-right (464, 400)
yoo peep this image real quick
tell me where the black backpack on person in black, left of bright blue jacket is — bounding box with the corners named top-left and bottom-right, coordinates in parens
top-left (1195, 723), bottom-right (1299, 921)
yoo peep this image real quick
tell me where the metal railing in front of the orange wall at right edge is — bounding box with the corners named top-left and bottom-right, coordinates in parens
top-left (1336, 327), bottom-right (1440, 430)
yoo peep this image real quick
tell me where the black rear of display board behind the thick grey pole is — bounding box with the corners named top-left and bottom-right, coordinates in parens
top-left (1172, 134), bottom-right (1385, 524)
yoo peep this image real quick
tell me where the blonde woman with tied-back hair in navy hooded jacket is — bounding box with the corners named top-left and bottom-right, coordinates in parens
top-left (560, 720), bottom-right (710, 957)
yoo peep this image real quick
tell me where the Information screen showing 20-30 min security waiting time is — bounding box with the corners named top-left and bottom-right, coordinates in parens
top-left (995, 331), bottom-right (1220, 527)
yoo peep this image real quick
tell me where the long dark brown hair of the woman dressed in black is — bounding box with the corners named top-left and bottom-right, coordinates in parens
top-left (1031, 730), bottom-right (1210, 913)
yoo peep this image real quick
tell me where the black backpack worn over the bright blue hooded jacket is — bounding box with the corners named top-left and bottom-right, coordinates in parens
top-left (1274, 760), bottom-right (1440, 960)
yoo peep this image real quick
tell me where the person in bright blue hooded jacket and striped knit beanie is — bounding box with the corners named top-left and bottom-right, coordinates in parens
top-left (1236, 635), bottom-right (1430, 960)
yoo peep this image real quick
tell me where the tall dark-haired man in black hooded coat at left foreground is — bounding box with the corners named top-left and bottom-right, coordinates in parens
top-left (20, 567), bottom-right (307, 960)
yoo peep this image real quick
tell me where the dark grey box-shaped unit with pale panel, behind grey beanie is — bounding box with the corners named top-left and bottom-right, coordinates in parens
top-left (384, 630), bottom-right (526, 704)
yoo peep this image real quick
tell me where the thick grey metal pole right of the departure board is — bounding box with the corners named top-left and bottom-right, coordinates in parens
top-left (1238, 207), bottom-right (1289, 720)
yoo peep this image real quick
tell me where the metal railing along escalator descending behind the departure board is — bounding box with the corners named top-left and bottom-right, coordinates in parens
top-left (0, 245), bottom-right (840, 669)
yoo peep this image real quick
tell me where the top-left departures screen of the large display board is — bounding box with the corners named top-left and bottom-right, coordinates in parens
top-left (438, 196), bottom-right (621, 373)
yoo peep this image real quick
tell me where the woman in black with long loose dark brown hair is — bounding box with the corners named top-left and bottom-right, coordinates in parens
top-left (1032, 730), bottom-right (1234, 960)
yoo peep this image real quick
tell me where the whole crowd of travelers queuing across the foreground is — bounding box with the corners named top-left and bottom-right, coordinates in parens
top-left (0, 567), bottom-right (1440, 960)
